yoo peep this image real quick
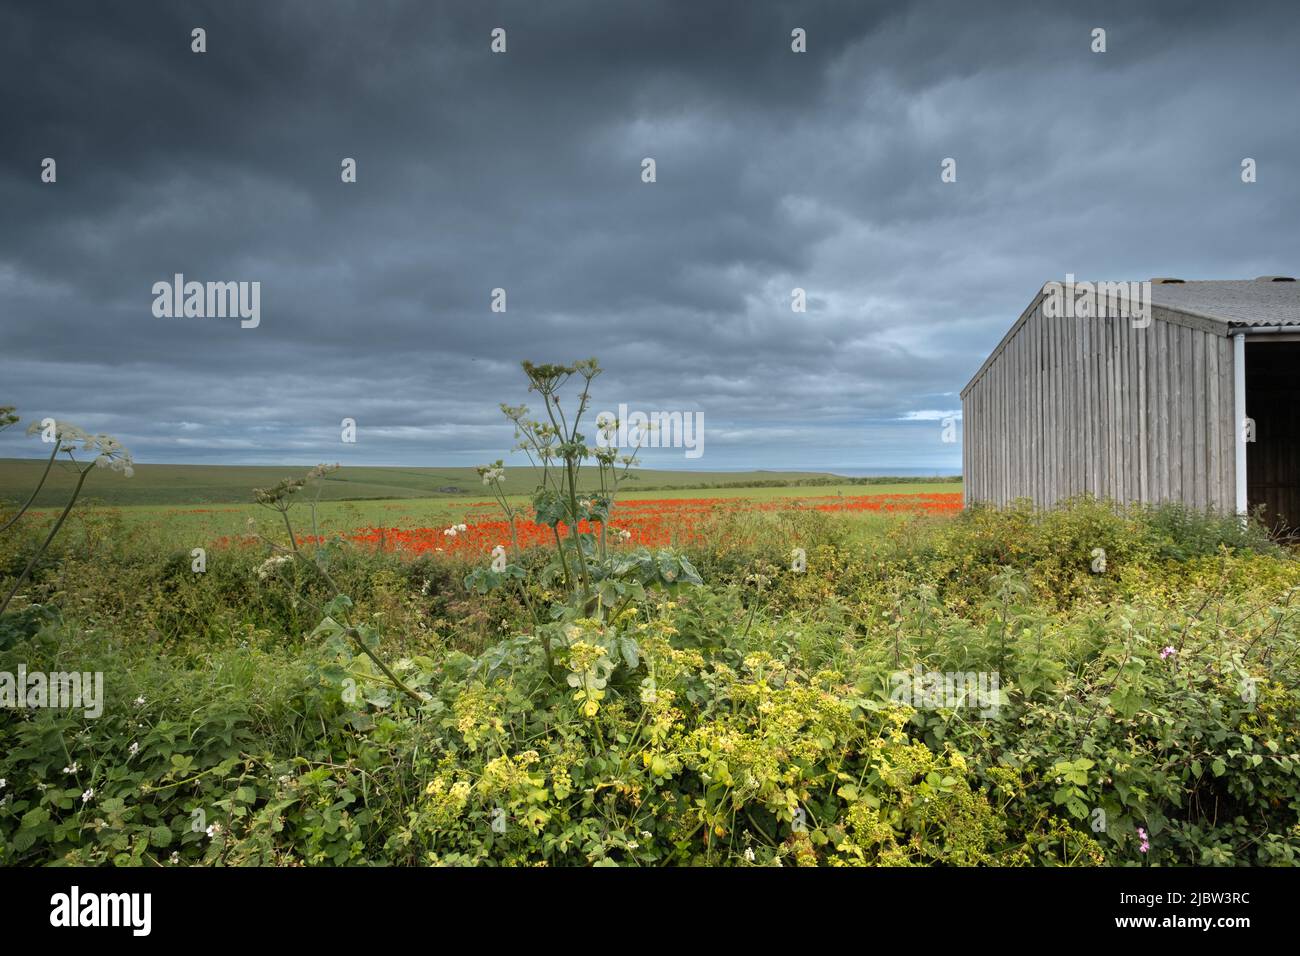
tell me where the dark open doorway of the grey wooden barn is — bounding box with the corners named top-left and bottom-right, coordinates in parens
top-left (1245, 338), bottom-right (1300, 535)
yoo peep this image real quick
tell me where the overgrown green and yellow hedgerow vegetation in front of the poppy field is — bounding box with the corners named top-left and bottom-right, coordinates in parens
top-left (0, 363), bottom-right (1300, 866)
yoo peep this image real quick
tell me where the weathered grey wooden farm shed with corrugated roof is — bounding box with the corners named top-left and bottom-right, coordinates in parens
top-left (962, 276), bottom-right (1300, 528)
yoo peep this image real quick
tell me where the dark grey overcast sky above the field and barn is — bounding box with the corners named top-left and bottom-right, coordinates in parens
top-left (0, 0), bottom-right (1300, 473)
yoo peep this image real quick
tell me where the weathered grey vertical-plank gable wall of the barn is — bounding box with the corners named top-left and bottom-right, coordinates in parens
top-left (962, 297), bottom-right (1235, 511)
